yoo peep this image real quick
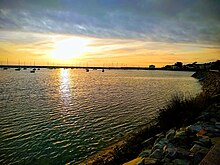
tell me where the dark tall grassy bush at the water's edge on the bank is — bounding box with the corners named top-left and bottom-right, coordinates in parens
top-left (158, 93), bottom-right (209, 130)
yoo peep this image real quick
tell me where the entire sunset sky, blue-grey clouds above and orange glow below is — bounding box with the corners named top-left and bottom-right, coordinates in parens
top-left (0, 0), bottom-right (220, 67)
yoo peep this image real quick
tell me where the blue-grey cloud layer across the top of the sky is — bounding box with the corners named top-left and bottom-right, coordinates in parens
top-left (0, 0), bottom-right (220, 43)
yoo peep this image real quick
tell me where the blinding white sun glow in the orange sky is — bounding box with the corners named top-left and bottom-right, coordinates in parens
top-left (51, 37), bottom-right (89, 60)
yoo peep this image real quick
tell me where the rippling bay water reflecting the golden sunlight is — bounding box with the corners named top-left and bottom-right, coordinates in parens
top-left (0, 69), bottom-right (201, 164)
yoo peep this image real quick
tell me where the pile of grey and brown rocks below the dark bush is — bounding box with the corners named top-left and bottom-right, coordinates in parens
top-left (125, 98), bottom-right (220, 165)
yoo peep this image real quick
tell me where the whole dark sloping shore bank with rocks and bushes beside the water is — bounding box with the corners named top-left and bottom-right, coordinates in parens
top-left (80, 71), bottom-right (220, 165)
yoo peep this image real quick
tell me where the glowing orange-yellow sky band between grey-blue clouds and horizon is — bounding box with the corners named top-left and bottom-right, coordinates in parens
top-left (0, 31), bottom-right (220, 67)
